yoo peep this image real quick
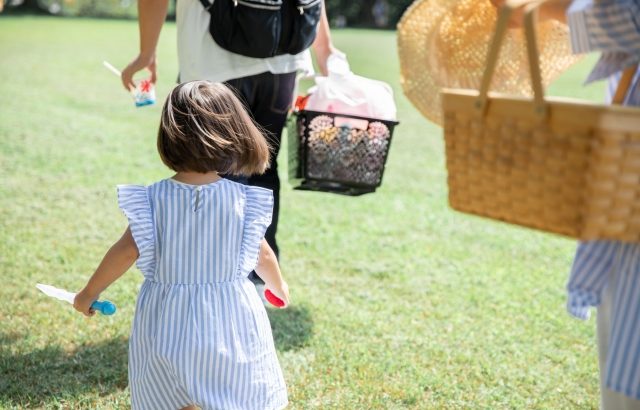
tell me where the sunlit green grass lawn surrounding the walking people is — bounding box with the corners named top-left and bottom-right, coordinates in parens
top-left (0, 16), bottom-right (602, 409)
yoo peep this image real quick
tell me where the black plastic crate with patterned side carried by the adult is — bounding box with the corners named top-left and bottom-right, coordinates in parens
top-left (288, 110), bottom-right (398, 196)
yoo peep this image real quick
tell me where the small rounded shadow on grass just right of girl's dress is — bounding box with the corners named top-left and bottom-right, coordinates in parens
top-left (267, 306), bottom-right (313, 351)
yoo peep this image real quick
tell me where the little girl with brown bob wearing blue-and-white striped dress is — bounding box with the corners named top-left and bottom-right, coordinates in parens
top-left (74, 81), bottom-right (289, 410)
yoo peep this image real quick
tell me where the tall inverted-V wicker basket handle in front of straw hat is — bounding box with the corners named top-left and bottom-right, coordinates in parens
top-left (476, 0), bottom-right (547, 118)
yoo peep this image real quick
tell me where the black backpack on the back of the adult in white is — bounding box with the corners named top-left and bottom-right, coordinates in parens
top-left (200, 0), bottom-right (322, 58)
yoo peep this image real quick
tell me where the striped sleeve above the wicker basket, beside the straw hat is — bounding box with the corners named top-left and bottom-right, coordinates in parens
top-left (567, 0), bottom-right (640, 56)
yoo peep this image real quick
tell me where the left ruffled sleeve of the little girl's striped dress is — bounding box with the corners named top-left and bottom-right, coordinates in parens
top-left (118, 185), bottom-right (155, 274)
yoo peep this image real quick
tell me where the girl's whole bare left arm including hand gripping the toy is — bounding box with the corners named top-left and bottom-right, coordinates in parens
top-left (73, 227), bottom-right (139, 316)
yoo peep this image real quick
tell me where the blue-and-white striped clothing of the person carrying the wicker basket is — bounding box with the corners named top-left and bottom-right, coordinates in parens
top-left (567, 0), bottom-right (640, 399)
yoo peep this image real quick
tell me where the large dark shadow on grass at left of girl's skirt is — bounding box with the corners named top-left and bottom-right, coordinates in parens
top-left (0, 334), bottom-right (127, 408)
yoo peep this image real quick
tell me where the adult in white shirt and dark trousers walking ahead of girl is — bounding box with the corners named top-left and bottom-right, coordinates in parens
top-left (121, 0), bottom-right (339, 295)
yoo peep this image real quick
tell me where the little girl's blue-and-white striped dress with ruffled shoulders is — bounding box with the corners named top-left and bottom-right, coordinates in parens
top-left (118, 179), bottom-right (287, 410)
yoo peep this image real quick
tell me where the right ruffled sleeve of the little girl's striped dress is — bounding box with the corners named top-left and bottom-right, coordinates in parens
top-left (241, 186), bottom-right (273, 274)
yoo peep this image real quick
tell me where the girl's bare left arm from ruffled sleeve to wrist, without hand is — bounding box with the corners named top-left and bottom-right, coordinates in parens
top-left (82, 229), bottom-right (138, 297)
